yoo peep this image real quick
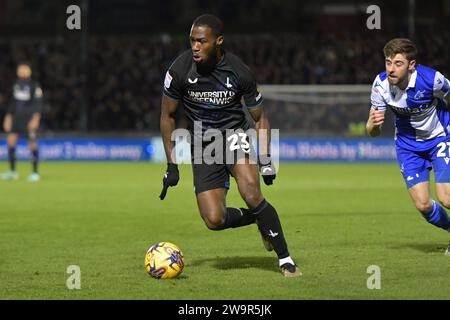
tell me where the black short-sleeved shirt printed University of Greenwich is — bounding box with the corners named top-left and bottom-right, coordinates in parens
top-left (163, 50), bottom-right (263, 133)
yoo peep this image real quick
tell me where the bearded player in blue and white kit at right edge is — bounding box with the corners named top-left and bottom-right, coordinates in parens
top-left (366, 38), bottom-right (450, 255)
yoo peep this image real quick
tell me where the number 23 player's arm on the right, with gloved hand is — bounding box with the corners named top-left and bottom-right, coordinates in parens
top-left (249, 106), bottom-right (276, 185)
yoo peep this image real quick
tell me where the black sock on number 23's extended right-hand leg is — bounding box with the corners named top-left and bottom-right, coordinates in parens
top-left (253, 200), bottom-right (289, 259)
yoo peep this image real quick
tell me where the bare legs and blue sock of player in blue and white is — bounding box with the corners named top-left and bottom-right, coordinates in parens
top-left (408, 182), bottom-right (450, 255)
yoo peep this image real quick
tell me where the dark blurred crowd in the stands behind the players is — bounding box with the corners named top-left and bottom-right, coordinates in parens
top-left (0, 32), bottom-right (450, 131)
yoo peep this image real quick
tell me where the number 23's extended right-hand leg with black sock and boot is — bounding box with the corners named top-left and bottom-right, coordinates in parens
top-left (233, 161), bottom-right (302, 277)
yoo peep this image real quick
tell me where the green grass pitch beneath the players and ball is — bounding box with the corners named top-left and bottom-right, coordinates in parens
top-left (0, 162), bottom-right (450, 299)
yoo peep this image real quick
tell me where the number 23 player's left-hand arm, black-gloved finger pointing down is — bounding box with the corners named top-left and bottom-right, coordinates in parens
top-left (159, 95), bottom-right (180, 200)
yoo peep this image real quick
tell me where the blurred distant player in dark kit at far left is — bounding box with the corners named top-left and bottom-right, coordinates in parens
top-left (1, 62), bottom-right (43, 182)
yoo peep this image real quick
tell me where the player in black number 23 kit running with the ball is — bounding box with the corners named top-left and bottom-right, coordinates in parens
top-left (160, 14), bottom-right (301, 277)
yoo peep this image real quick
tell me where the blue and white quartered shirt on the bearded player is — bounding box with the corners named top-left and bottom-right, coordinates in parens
top-left (371, 65), bottom-right (450, 151)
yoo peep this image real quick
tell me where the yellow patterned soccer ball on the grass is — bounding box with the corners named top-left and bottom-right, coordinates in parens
top-left (144, 242), bottom-right (184, 279)
